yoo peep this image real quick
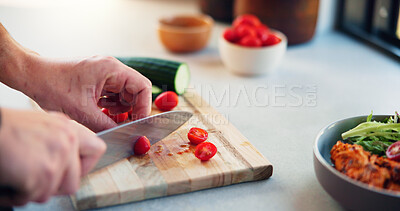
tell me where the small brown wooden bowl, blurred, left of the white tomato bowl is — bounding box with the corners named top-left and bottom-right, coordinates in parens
top-left (158, 15), bottom-right (214, 53)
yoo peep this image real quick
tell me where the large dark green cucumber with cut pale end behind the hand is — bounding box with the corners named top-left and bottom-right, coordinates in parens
top-left (117, 57), bottom-right (190, 95)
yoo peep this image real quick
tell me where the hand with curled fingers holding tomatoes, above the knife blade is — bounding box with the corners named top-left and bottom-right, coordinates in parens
top-left (24, 56), bottom-right (151, 132)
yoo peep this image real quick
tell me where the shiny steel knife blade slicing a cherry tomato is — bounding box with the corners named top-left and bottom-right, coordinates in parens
top-left (90, 111), bottom-right (193, 172)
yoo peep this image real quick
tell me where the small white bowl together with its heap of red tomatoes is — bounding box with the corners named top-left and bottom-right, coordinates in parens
top-left (219, 14), bottom-right (287, 76)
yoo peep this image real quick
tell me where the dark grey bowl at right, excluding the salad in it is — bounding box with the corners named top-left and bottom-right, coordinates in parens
top-left (314, 115), bottom-right (400, 210)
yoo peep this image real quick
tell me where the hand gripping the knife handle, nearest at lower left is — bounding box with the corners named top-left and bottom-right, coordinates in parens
top-left (0, 109), bottom-right (106, 206)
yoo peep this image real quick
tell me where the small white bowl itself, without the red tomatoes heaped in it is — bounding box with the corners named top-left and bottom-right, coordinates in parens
top-left (219, 30), bottom-right (287, 76)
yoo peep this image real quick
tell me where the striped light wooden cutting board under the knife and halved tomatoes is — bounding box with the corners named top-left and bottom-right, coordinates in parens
top-left (59, 90), bottom-right (272, 210)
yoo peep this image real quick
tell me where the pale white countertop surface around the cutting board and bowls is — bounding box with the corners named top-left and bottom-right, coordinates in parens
top-left (0, 0), bottom-right (400, 210)
